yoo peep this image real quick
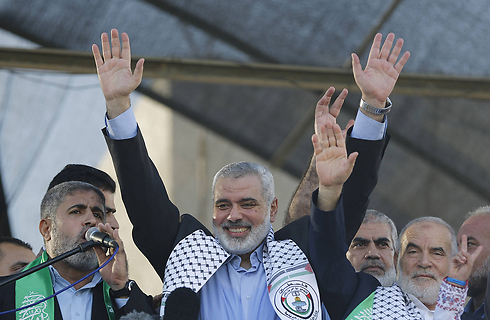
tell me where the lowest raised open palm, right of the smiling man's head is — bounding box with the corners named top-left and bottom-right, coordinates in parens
top-left (311, 122), bottom-right (358, 211)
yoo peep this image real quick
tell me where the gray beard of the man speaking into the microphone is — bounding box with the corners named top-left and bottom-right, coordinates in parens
top-left (50, 222), bottom-right (99, 271)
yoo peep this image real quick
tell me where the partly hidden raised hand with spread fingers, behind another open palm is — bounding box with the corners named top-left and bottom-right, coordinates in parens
top-left (315, 87), bottom-right (354, 138)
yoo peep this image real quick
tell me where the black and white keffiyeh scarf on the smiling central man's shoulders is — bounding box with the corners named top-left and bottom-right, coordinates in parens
top-left (160, 227), bottom-right (321, 320)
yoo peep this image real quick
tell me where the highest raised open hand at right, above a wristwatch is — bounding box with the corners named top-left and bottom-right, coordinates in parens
top-left (352, 33), bottom-right (410, 108)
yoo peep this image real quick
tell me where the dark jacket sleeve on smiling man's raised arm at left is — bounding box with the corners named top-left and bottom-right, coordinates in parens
top-left (103, 128), bottom-right (180, 280)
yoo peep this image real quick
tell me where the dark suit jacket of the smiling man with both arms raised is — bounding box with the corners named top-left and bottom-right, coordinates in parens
top-left (103, 128), bottom-right (389, 319)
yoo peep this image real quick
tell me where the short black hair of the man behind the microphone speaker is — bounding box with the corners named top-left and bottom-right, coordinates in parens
top-left (48, 164), bottom-right (116, 193)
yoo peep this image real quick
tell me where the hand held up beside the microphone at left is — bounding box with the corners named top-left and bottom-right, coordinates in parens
top-left (94, 223), bottom-right (129, 290)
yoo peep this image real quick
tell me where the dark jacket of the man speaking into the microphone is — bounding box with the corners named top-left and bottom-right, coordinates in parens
top-left (0, 277), bottom-right (155, 320)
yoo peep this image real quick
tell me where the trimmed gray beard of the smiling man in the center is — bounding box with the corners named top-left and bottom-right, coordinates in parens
top-left (213, 210), bottom-right (271, 255)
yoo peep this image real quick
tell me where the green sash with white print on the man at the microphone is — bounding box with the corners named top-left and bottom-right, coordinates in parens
top-left (15, 251), bottom-right (116, 320)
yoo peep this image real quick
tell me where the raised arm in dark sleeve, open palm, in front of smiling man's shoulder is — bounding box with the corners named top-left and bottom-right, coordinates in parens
top-left (308, 123), bottom-right (370, 319)
